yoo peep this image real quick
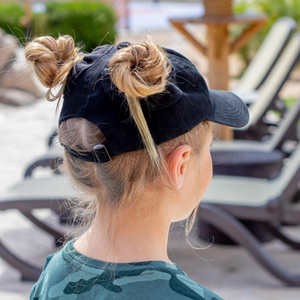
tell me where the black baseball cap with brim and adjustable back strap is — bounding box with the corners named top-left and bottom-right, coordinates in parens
top-left (59, 42), bottom-right (249, 163)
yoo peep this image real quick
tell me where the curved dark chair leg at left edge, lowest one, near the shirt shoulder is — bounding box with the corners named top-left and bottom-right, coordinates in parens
top-left (0, 241), bottom-right (42, 281)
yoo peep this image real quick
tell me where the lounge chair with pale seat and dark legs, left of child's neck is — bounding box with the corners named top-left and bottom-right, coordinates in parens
top-left (0, 175), bottom-right (75, 281)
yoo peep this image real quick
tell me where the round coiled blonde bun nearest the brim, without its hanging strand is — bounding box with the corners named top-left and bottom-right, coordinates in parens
top-left (109, 41), bottom-right (170, 98)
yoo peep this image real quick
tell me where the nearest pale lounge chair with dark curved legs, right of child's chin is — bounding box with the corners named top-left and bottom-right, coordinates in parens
top-left (198, 144), bottom-right (300, 286)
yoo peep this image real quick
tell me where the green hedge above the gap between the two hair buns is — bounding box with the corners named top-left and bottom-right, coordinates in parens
top-left (38, 2), bottom-right (116, 51)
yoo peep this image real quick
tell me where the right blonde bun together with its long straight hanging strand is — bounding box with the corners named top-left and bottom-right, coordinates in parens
top-left (109, 41), bottom-right (171, 168)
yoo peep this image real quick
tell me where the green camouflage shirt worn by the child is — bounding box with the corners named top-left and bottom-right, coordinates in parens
top-left (30, 241), bottom-right (222, 300)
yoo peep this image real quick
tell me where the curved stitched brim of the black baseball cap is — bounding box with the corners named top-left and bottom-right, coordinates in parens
top-left (206, 90), bottom-right (249, 128)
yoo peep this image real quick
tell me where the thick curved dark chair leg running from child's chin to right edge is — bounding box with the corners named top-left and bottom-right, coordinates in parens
top-left (198, 203), bottom-right (300, 286)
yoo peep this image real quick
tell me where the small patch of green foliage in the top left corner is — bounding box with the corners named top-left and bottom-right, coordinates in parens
top-left (0, 3), bottom-right (27, 41)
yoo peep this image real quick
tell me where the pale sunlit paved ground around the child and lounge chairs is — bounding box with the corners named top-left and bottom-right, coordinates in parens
top-left (0, 0), bottom-right (300, 300)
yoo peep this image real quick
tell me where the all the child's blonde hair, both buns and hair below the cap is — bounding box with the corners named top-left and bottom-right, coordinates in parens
top-left (25, 36), bottom-right (208, 234)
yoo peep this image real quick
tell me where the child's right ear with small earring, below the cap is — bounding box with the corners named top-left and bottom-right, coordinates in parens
top-left (167, 145), bottom-right (191, 189)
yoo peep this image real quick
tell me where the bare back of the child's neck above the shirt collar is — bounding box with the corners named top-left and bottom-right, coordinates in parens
top-left (74, 199), bottom-right (171, 263)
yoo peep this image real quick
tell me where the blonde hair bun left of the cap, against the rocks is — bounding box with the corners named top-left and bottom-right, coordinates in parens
top-left (25, 35), bottom-right (83, 101)
